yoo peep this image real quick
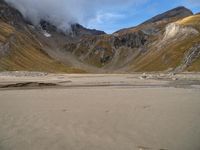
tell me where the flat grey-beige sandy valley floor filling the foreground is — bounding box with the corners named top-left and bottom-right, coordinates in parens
top-left (0, 72), bottom-right (200, 150)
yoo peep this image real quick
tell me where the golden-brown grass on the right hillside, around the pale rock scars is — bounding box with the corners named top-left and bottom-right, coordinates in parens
top-left (130, 15), bottom-right (200, 72)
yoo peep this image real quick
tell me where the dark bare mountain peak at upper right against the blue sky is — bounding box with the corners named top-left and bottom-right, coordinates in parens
top-left (143, 6), bottom-right (193, 24)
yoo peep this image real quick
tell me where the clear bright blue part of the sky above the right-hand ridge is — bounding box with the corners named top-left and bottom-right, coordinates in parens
top-left (85, 0), bottom-right (200, 33)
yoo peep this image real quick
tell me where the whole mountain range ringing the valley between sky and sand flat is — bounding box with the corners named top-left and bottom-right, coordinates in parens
top-left (0, 0), bottom-right (200, 73)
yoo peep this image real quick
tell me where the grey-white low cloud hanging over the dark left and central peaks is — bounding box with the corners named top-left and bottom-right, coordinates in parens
top-left (6, 0), bottom-right (148, 30)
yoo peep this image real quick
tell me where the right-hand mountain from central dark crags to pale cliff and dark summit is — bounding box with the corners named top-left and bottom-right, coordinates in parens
top-left (61, 7), bottom-right (200, 72)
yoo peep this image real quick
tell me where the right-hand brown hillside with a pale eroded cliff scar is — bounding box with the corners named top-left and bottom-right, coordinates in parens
top-left (128, 15), bottom-right (200, 71)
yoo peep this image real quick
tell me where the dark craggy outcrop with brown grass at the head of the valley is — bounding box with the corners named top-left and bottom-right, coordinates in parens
top-left (64, 31), bottom-right (148, 67)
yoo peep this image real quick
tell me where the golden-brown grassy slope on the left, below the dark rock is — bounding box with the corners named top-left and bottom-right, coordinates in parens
top-left (0, 22), bottom-right (84, 73)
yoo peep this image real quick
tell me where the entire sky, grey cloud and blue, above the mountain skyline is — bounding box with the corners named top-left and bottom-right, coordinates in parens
top-left (6, 0), bottom-right (200, 33)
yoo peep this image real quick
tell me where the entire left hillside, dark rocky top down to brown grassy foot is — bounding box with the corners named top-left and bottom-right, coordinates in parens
top-left (0, 1), bottom-right (84, 73)
